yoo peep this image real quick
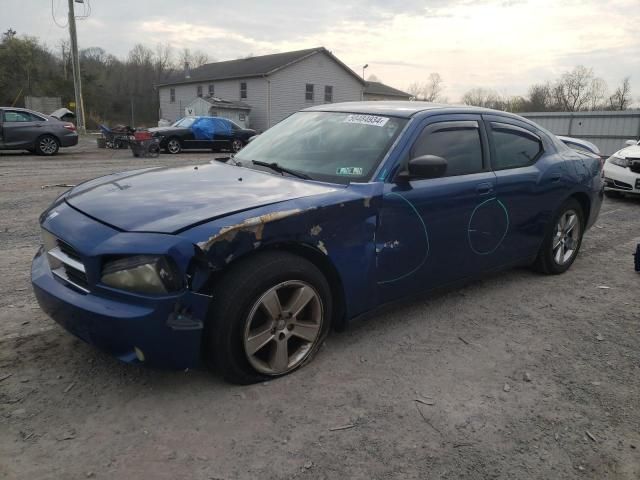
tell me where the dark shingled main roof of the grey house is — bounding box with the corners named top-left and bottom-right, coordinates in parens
top-left (156, 47), bottom-right (362, 87)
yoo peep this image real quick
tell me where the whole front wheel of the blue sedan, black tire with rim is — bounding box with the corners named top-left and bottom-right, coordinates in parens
top-left (204, 251), bottom-right (332, 385)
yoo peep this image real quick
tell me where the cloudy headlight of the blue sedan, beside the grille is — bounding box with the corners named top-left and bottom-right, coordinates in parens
top-left (101, 255), bottom-right (182, 295)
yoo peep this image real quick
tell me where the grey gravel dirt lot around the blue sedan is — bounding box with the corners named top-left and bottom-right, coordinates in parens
top-left (0, 137), bottom-right (640, 479)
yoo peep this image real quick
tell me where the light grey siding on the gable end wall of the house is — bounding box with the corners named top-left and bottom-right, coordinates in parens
top-left (269, 52), bottom-right (363, 125)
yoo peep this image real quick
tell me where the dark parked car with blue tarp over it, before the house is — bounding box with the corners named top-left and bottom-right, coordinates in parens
top-left (149, 117), bottom-right (256, 153)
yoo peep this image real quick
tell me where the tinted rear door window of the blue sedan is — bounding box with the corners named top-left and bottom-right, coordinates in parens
top-left (491, 123), bottom-right (543, 170)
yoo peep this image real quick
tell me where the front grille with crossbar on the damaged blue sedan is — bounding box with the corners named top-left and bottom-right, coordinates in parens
top-left (42, 230), bottom-right (89, 293)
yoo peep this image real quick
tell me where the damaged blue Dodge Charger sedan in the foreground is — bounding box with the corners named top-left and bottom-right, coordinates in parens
top-left (31, 102), bottom-right (603, 383)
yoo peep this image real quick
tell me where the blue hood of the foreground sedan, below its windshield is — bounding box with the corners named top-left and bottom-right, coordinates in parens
top-left (66, 163), bottom-right (335, 233)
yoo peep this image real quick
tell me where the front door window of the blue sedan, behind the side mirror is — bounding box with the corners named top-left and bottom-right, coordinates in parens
top-left (411, 121), bottom-right (483, 177)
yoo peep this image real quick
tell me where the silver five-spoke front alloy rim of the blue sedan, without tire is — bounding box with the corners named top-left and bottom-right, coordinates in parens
top-left (243, 280), bottom-right (323, 376)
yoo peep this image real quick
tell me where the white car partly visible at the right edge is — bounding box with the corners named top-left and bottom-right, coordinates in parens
top-left (604, 140), bottom-right (640, 196)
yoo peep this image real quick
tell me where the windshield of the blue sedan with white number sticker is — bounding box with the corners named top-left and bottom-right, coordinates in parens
top-left (235, 112), bottom-right (407, 184)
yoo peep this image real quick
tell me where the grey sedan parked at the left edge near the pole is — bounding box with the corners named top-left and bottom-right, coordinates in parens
top-left (0, 107), bottom-right (78, 155)
